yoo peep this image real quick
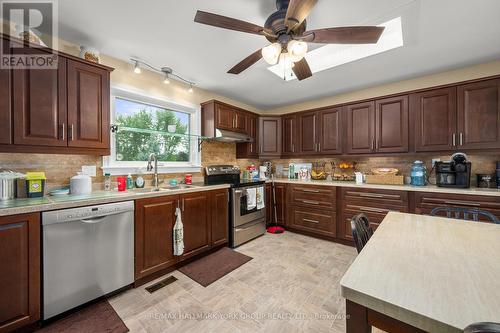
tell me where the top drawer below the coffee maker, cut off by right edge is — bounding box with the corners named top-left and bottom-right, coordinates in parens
top-left (415, 193), bottom-right (500, 210)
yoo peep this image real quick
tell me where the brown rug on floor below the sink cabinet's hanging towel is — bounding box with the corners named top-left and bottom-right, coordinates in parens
top-left (179, 247), bottom-right (252, 287)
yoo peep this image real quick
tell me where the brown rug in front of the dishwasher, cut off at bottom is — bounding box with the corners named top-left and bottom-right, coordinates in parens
top-left (37, 300), bottom-right (128, 333)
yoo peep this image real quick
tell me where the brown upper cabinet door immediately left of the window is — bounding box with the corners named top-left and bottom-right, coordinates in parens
top-left (68, 60), bottom-right (110, 149)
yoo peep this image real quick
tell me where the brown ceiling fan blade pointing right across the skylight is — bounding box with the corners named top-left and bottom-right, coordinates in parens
top-left (301, 27), bottom-right (385, 44)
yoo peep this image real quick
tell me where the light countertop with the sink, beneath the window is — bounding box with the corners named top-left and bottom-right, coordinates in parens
top-left (0, 184), bottom-right (229, 216)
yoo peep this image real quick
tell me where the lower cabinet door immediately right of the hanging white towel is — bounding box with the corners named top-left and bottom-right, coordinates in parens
top-left (181, 192), bottom-right (211, 260)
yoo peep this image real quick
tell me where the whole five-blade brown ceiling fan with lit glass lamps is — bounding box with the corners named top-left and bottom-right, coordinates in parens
top-left (194, 0), bottom-right (384, 80)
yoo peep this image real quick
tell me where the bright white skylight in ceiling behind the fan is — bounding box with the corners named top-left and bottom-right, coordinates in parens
top-left (268, 17), bottom-right (404, 81)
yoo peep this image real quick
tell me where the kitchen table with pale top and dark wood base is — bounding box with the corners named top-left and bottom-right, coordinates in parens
top-left (340, 212), bottom-right (500, 333)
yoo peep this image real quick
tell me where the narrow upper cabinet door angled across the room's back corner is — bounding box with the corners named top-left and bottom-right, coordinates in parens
top-left (259, 117), bottom-right (281, 157)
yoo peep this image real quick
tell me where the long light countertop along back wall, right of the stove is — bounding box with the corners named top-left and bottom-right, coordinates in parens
top-left (274, 178), bottom-right (500, 197)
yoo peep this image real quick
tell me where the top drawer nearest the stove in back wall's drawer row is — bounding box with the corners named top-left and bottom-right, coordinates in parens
top-left (292, 185), bottom-right (336, 210)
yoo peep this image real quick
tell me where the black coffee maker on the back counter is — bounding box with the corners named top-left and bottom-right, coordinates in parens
top-left (436, 153), bottom-right (472, 188)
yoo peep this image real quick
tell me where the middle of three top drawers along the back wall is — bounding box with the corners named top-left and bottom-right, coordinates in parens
top-left (342, 188), bottom-right (408, 208)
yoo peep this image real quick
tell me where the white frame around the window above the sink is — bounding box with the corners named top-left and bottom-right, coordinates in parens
top-left (102, 87), bottom-right (201, 176)
